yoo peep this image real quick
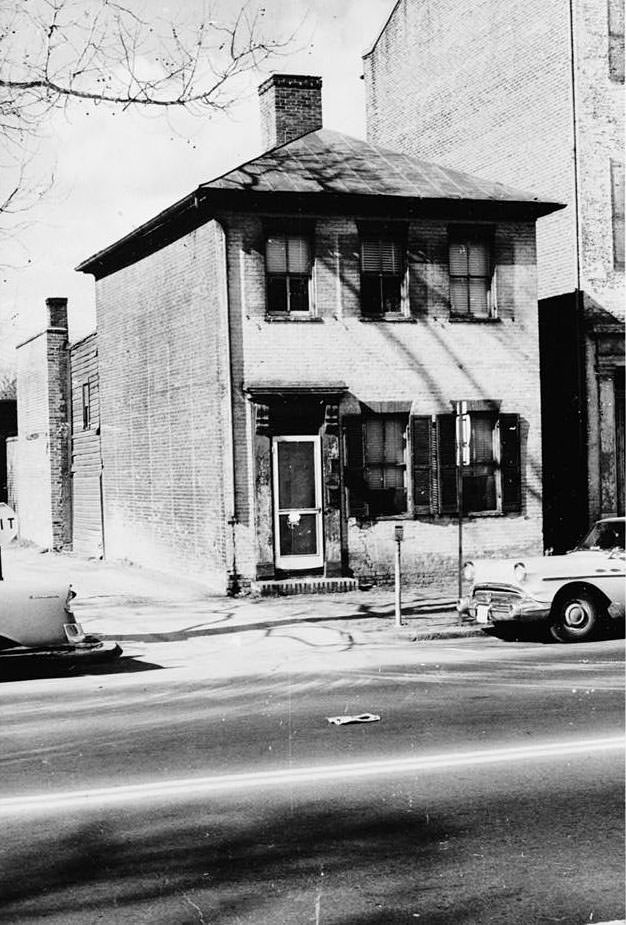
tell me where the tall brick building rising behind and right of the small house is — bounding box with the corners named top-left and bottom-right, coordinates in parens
top-left (364, 0), bottom-right (624, 548)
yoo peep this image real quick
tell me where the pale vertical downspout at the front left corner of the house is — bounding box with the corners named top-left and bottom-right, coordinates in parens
top-left (214, 219), bottom-right (241, 597)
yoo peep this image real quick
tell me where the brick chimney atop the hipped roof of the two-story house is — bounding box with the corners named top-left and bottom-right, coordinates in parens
top-left (259, 74), bottom-right (322, 151)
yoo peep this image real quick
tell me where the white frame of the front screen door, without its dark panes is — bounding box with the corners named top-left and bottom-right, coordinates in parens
top-left (272, 434), bottom-right (324, 572)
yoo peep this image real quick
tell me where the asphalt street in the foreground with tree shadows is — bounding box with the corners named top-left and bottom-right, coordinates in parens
top-left (0, 627), bottom-right (624, 925)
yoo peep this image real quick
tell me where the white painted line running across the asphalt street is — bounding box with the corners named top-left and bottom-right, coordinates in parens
top-left (0, 736), bottom-right (624, 816)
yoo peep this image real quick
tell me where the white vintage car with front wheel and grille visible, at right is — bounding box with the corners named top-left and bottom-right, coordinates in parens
top-left (458, 517), bottom-right (626, 642)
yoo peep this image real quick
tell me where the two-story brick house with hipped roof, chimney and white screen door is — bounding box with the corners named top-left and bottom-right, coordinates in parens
top-left (77, 75), bottom-right (559, 588)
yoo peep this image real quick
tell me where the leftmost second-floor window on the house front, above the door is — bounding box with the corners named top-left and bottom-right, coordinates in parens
top-left (265, 234), bottom-right (312, 315)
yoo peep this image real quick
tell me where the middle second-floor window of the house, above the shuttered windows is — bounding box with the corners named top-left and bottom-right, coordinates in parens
top-left (361, 236), bottom-right (405, 317)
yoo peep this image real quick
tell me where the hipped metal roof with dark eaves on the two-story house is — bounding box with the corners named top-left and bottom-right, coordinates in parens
top-left (77, 129), bottom-right (564, 278)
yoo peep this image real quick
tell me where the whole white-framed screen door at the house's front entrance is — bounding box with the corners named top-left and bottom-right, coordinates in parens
top-left (272, 436), bottom-right (323, 570)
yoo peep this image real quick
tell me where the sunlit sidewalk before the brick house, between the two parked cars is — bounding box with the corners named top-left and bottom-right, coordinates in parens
top-left (2, 545), bottom-right (482, 645)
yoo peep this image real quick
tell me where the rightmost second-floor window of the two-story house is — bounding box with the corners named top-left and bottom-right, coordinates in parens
top-left (449, 229), bottom-right (495, 318)
